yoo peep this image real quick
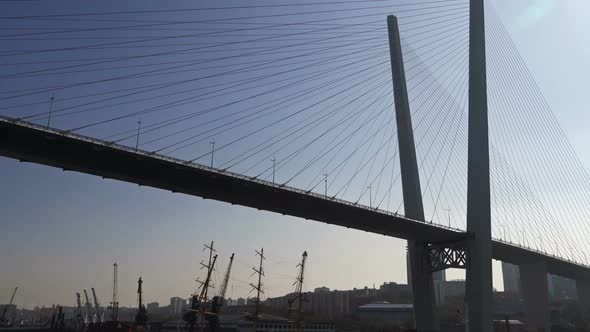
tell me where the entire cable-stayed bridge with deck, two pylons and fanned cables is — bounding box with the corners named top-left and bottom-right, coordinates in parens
top-left (0, 0), bottom-right (590, 331)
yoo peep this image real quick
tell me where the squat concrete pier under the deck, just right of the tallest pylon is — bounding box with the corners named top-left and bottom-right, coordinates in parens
top-left (520, 263), bottom-right (550, 332)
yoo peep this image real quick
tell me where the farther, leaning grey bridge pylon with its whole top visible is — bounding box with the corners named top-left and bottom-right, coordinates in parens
top-left (387, 15), bottom-right (438, 332)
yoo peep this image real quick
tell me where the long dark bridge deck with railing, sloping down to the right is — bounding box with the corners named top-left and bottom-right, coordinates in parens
top-left (0, 118), bottom-right (590, 279)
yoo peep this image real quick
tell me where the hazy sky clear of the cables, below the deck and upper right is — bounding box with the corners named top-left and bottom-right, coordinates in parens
top-left (0, 0), bottom-right (590, 307)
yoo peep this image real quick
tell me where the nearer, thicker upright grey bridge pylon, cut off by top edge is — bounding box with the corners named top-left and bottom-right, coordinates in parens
top-left (466, 0), bottom-right (493, 332)
